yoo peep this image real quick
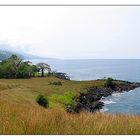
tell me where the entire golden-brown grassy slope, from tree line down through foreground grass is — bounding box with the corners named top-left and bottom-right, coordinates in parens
top-left (0, 78), bottom-right (140, 134)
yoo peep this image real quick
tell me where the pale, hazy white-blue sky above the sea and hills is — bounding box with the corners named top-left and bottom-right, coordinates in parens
top-left (0, 6), bottom-right (140, 59)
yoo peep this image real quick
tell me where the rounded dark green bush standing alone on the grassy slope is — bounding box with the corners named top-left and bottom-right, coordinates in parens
top-left (36, 95), bottom-right (49, 107)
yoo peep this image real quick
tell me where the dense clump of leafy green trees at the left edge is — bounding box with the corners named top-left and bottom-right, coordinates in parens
top-left (0, 55), bottom-right (38, 78)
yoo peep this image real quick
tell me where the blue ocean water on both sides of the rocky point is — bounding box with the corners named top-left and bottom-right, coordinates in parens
top-left (31, 59), bottom-right (140, 114)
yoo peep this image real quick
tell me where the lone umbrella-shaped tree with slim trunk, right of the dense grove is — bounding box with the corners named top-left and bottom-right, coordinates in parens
top-left (37, 63), bottom-right (51, 77)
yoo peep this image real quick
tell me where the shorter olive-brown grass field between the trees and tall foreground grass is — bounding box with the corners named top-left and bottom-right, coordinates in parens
top-left (0, 77), bottom-right (101, 106)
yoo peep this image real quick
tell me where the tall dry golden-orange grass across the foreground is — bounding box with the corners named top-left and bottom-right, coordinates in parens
top-left (0, 103), bottom-right (140, 135)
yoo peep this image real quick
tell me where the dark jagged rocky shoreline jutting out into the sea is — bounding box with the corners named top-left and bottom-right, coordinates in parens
top-left (66, 80), bottom-right (140, 113)
